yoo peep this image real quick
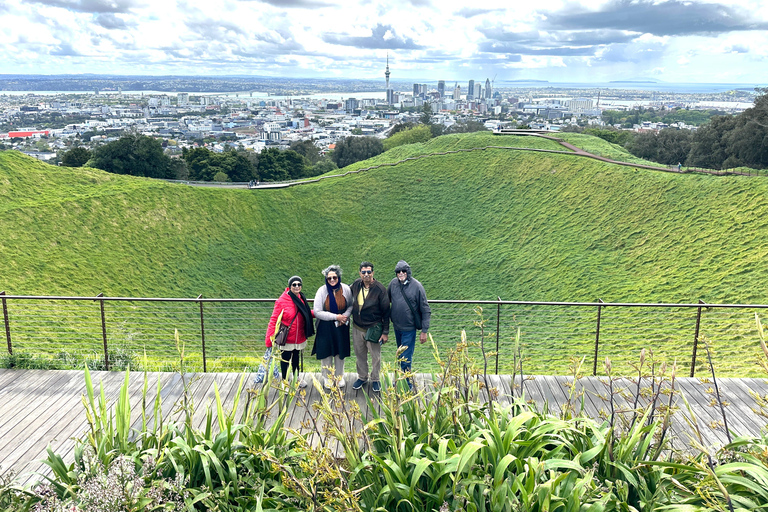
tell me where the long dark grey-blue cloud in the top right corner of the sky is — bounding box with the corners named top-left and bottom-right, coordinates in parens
top-left (541, 0), bottom-right (768, 36)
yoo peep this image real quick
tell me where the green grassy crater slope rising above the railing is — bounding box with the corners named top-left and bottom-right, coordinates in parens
top-left (0, 133), bottom-right (768, 374)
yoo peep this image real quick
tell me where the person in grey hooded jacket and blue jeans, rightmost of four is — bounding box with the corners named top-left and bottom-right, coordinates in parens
top-left (387, 260), bottom-right (432, 385)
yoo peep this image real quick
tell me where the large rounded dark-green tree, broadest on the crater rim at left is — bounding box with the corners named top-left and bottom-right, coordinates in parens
top-left (88, 134), bottom-right (174, 178)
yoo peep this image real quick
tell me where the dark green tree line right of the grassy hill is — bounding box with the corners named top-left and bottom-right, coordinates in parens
top-left (564, 88), bottom-right (768, 169)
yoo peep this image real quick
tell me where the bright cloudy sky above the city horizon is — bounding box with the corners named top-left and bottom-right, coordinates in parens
top-left (0, 0), bottom-right (768, 84)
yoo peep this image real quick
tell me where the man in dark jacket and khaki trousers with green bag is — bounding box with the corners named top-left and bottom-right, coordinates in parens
top-left (351, 261), bottom-right (389, 393)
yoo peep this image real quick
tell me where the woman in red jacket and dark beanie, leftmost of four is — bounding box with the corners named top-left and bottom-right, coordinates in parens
top-left (265, 276), bottom-right (315, 388)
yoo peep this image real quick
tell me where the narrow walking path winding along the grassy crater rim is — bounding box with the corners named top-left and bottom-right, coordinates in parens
top-left (166, 130), bottom-right (754, 190)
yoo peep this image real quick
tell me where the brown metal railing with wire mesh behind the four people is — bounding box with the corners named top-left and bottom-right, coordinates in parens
top-left (0, 292), bottom-right (768, 376)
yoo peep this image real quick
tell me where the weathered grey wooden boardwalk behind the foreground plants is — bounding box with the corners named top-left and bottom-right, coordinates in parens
top-left (0, 369), bottom-right (768, 483)
